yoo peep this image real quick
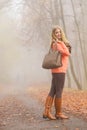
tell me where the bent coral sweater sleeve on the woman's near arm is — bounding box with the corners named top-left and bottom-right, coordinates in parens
top-left (57, 42), bottom-right (70, 56)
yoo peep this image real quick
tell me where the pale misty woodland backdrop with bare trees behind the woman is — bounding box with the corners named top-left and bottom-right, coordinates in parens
top-left (0, 0), bottom-right (87, 89)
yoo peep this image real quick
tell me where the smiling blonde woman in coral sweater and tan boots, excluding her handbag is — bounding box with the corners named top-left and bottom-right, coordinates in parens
top-left (43, 26), bottom-right (71, 120)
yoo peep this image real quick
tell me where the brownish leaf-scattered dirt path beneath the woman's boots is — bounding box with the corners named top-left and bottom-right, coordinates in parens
top-left (0, 87), bottom-right (87, 130)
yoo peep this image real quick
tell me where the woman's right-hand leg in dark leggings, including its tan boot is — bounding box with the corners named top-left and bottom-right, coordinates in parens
top-left (55, 73), bottom-right (68, 119)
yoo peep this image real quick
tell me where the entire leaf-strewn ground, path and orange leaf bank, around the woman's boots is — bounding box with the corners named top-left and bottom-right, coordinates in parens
top-left (0, 86), bottom-right (87, 130)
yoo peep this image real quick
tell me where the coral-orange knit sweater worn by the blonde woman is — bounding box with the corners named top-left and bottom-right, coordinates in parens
top-left (51, 42), bottom-right (70, 73)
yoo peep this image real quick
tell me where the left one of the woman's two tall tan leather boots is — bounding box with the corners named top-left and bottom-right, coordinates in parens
top-left (43, 96), bottom-right (56, 120)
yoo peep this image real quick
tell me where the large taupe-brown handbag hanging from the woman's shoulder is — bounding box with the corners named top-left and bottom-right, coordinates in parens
top-left (42, 44), bottom-right (62, 69)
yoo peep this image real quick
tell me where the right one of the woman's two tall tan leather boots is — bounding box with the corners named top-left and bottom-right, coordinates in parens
top-left (55, 98), bottom-right (68, 119)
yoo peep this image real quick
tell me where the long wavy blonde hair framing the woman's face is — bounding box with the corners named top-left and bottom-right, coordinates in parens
top-left (52, 25), bottom-right (69, 46)
